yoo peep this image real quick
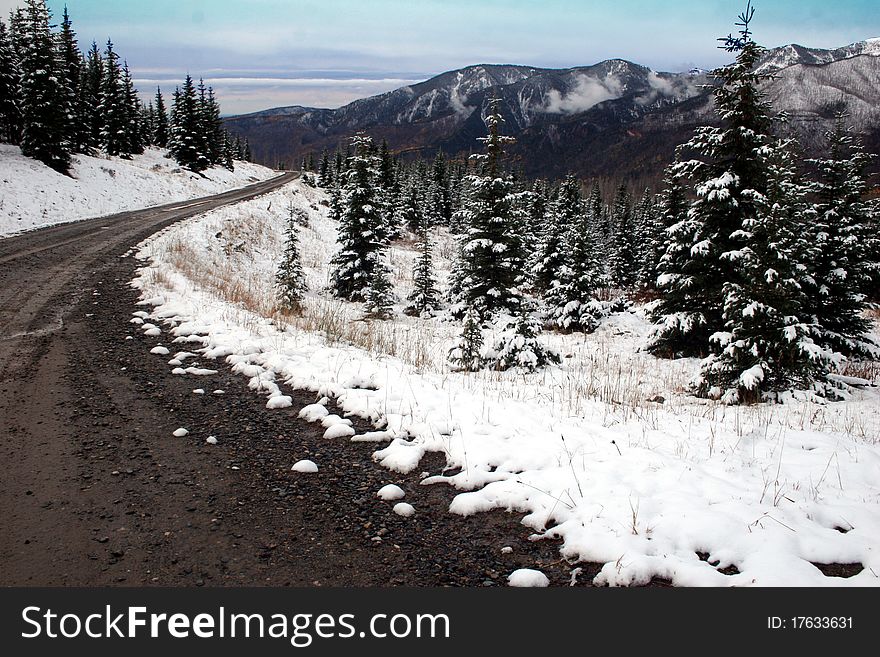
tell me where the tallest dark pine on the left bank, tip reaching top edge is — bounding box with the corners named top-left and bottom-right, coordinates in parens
top-left (19, 0), bottom-right (71, 173)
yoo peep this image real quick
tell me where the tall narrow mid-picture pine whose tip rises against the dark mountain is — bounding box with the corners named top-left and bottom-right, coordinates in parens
top-left (450, 98), bottom-right (523, 314)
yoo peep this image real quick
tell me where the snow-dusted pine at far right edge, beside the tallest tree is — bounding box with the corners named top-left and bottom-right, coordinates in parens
top-left (807, 113), bottom-right (880, 356)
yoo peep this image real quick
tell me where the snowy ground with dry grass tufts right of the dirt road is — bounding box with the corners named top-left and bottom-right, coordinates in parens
top-left (133, 178), bottom-right (880, 586)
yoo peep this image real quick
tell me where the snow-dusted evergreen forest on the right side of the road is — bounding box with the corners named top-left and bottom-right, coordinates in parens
top-left (284, 5), bottom-right (880, 403)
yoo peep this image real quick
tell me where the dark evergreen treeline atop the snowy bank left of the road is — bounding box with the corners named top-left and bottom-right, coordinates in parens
top-left (0, 0), bottom-right (250, 173)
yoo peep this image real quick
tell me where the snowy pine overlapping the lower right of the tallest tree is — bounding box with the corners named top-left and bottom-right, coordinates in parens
top-left (698, 142), bottom-right (833, 403)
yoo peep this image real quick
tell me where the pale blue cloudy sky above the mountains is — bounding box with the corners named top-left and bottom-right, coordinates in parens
top-left (0, 0), bottom-right (880, 114)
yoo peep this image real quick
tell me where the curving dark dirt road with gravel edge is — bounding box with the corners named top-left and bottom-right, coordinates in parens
top-left (0, 174), bottom-right (595, 586)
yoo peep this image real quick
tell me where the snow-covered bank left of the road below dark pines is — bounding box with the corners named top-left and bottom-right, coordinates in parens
top-left (0, 144), bottom-right (276, 237)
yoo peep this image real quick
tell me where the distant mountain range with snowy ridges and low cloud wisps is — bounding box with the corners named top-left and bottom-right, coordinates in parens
top-left (225, 39), bottom-right (880, 185)
